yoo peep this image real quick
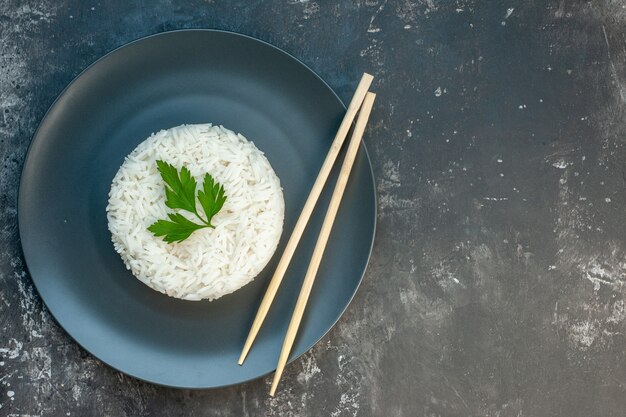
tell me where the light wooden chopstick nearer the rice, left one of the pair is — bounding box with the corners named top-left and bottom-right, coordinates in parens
top-left (239, 73), bottom-right (374, 365)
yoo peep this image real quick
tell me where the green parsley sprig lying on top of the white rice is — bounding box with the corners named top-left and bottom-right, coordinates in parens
top-left (148, 160), bottom-right (226, 243)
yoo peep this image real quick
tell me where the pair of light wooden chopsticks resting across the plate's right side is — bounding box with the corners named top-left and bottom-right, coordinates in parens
top-left (239, 73), bottom-right (376, 396)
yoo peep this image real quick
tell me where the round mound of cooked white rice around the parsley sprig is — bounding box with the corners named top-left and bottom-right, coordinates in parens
top-left (106, 124), bottom-right (285, 300)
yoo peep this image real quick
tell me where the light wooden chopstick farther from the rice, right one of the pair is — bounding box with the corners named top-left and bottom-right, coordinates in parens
top-left (270, 92), bottom-right (376, 397)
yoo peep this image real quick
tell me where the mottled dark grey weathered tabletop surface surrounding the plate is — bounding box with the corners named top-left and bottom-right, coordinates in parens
top-left (0, 0), bottom-right (626, 417)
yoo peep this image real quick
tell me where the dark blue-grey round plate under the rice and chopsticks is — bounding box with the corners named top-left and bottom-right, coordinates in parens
top-left (18, 30), bottom-right (376, 388)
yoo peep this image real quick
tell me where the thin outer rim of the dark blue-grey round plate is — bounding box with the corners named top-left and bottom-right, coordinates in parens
top-left (16, 28), bottom-right (378, 390)
